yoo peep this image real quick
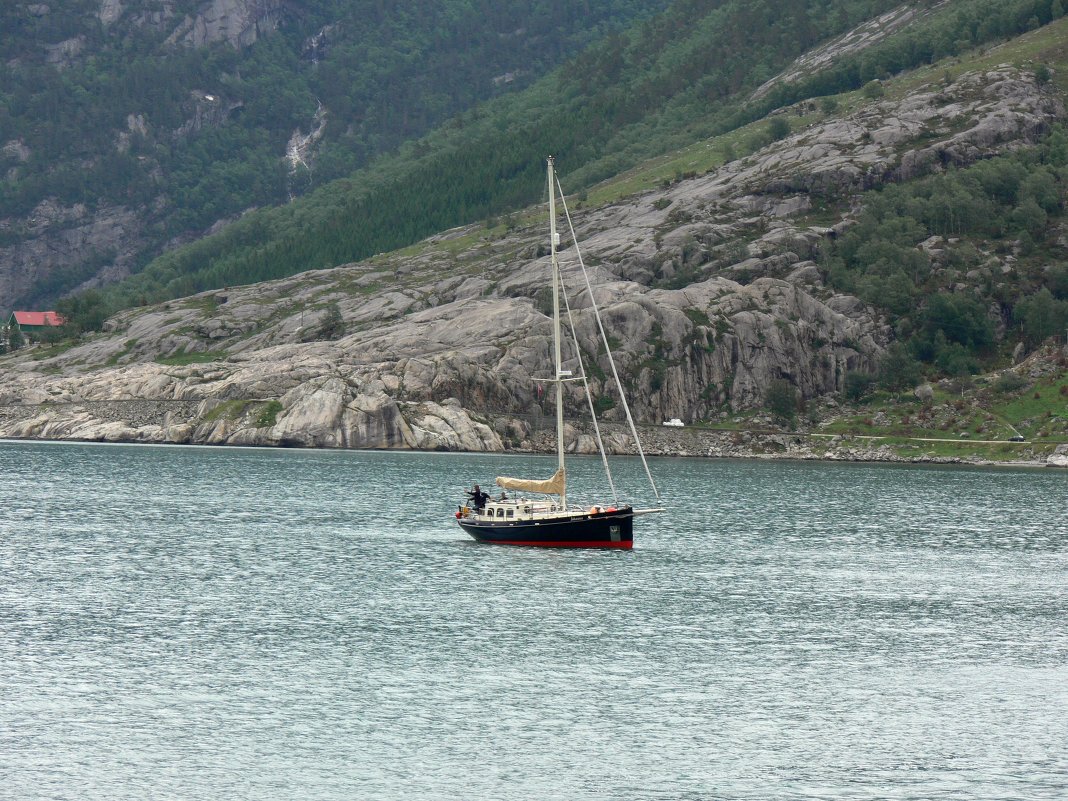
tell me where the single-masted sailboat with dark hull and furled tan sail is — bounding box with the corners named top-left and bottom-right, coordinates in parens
top-left (456, 157), bottom-right (663, 549)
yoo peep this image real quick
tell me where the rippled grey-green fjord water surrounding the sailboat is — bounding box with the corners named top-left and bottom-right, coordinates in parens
top-left (0, 443), bottom-right (1068, 801)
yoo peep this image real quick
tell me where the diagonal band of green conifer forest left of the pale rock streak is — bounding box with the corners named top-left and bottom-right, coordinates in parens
top-left (50, 0), bottom-right (894, 307)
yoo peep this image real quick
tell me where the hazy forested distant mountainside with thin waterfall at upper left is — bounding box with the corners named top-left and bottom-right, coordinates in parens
top-left (0, 0), bottom-right (666, 302)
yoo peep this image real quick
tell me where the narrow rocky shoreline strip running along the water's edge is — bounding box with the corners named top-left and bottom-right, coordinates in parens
top-left (0, 398), bottom-right (1068, 468)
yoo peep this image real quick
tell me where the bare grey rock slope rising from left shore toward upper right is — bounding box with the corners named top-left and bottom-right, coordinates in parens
top-left (0, 68), bottom-right (1063, 451)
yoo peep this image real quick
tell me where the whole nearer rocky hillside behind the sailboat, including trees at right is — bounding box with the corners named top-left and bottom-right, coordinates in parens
top-left (0, 20), bottom-right (1068, 463)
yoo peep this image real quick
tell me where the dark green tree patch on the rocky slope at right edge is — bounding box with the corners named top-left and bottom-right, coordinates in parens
top-left (820, 128), bottom-right (1068, 389)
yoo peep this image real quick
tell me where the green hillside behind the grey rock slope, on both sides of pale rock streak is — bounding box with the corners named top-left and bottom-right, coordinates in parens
top-left (73, 0), bottom-right (1059, 322)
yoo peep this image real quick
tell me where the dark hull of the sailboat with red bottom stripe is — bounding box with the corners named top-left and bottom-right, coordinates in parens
top-left (457, 506), bottom-right (634, 549)
